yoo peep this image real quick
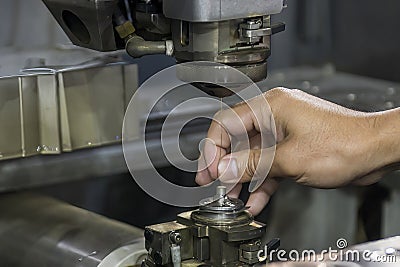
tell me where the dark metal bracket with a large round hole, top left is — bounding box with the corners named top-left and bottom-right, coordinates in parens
top-left (43, 0), bottom-right (118, 51)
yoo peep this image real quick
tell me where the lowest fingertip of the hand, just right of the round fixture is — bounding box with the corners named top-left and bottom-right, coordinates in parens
top-left (246, 178), bottom-right (279, 216)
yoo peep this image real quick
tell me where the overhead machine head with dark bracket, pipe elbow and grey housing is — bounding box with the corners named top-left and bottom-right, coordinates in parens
top-left (43, 0), bottom-right (286, 97)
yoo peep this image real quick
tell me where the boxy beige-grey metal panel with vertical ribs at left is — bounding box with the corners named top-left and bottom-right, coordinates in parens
top-left (0, 59), bottom-right (138, 159)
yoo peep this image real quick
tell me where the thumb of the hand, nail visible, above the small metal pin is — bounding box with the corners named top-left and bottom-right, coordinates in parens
top-left (218, 148), bottom-right (274, 184)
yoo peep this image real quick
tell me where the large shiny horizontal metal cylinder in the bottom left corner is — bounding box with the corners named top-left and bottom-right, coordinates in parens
top-left (0, 193), bottom-right (146, 267)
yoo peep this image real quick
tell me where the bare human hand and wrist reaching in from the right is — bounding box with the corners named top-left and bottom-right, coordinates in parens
top-left (196, 88), bottom-right (400, 215)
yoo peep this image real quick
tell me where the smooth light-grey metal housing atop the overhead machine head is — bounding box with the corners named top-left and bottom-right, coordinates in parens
top-left (163, 0), bottom-right (286, 22)
